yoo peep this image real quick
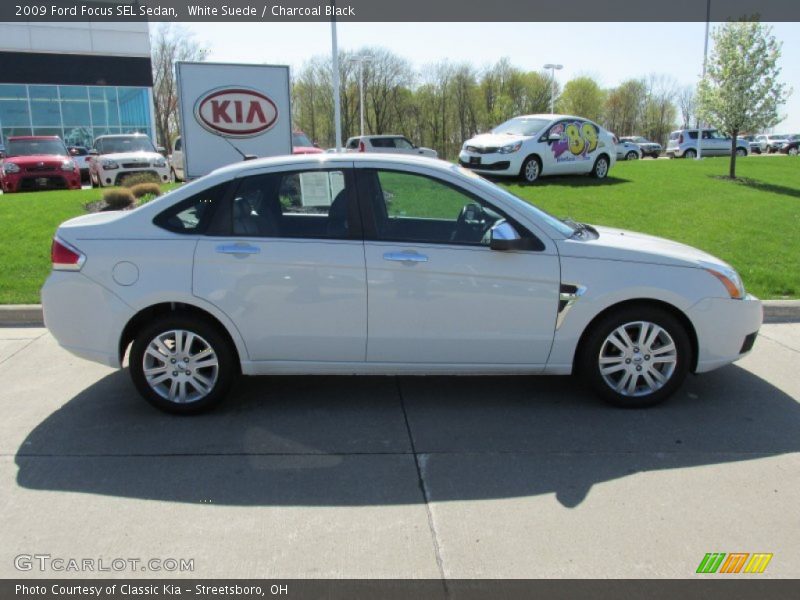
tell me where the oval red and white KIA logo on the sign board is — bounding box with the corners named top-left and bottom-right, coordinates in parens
top-left (194, 87), bottom-right (278, 137)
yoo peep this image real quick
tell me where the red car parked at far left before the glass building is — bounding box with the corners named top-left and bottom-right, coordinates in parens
top-left (0, 135), bottom-right (81, 194)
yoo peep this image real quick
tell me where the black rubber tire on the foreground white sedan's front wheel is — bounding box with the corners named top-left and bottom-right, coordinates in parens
top-left (576, 305), bottom-right (692, 408)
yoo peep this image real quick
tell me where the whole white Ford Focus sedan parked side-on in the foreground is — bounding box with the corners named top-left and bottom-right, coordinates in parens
top-left (42, 154), bottom-right (762, 413)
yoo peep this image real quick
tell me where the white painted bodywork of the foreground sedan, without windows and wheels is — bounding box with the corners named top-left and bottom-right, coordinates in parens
top-left (42, 154), bottom-right (761, 384)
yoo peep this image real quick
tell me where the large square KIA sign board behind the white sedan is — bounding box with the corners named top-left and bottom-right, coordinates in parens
top-left (176, 62), bottom-right (292, 179)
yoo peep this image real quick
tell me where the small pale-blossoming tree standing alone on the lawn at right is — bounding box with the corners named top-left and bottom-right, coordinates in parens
top-left (697, 21), bottom-right (787, 179)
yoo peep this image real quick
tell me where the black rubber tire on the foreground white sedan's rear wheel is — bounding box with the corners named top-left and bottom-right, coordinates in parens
top-left (129, 314), bottom-right (238, 415)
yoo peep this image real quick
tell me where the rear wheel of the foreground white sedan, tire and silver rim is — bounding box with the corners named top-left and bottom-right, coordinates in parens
top-left (129, 315), bottom-right (236, 414)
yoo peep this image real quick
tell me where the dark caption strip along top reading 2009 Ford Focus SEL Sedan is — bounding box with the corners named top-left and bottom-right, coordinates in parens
top-left (0, 0), bottom-right (800, 22)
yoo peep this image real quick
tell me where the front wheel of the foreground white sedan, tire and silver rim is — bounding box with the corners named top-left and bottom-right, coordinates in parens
top-left (578, 306), bottom-right (692, 408)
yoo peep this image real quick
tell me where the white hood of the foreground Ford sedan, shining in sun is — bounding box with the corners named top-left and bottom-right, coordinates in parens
top-left (561, 226), bottom-right (730, 268)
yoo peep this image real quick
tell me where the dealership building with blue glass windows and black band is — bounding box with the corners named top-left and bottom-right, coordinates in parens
top-left (0, 22), bottom-right (155, 147)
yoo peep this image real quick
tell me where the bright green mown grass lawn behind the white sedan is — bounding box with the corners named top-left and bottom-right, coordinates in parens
top-left (0, 156), bottom-right (800, 304)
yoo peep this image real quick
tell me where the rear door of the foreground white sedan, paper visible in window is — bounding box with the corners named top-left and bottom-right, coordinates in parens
top-left (193, 168), bottom-right (367, 362)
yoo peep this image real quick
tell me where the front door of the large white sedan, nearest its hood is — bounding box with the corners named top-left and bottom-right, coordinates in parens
top-left (356, 163), bottom-right (560, 371)
